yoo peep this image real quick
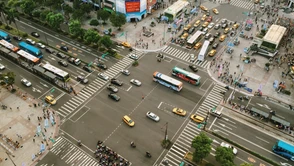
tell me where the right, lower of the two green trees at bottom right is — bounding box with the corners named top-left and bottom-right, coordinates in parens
top-left (215, 146), bottom-right (235, 166)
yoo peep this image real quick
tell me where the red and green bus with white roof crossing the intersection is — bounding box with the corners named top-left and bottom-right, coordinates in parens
top-left (172, 67), bottom-right (201, 85)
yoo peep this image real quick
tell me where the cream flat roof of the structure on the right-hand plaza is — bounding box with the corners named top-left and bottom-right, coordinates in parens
top-left (263, 24), bottom-right (286, 45)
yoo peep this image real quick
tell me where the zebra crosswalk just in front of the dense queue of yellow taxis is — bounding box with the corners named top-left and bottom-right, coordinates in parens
top-left (162, 46), bottom-right (209, 68)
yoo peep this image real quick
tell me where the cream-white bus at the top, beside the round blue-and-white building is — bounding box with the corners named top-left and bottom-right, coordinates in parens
top-left (163, 0), bottom-right (189, 21)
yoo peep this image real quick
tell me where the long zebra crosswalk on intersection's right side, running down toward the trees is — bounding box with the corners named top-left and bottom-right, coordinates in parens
top-left (159, 84), bottom-right (226, 166)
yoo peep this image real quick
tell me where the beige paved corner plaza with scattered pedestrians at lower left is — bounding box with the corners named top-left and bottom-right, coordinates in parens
top-left (0, 87), bottom-right (59, 166)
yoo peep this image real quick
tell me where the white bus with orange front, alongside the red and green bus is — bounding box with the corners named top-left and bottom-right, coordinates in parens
top-left (153, 71), bottom-right (183, 92)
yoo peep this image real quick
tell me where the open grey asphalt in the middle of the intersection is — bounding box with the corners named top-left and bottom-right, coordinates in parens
top-left (56, 53), bottom-right (212, 165)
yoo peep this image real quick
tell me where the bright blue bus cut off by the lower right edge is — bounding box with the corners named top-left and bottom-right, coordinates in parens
top-left (272, 140), bottom-right (294, 161)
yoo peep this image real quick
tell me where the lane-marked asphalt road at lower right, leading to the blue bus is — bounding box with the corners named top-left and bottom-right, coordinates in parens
top-left (208, 107), bottom-right (287, 163)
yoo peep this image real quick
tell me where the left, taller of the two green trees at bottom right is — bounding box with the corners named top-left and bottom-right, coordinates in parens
top-left (192, 133), bottom-right (212, 163)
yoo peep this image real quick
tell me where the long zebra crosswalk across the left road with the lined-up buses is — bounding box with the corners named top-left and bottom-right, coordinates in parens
top-left (57, 51), bottom-right (144, 118)
